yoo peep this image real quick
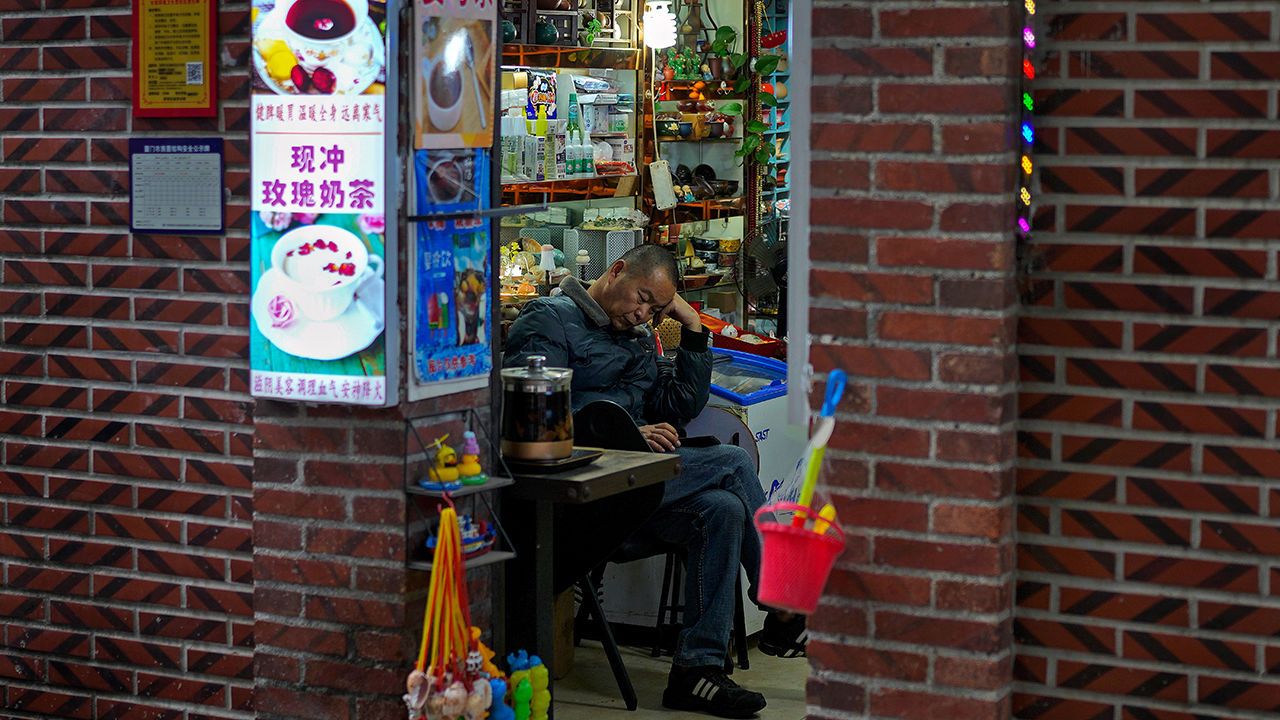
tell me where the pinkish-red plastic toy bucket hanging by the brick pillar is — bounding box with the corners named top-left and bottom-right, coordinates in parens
top-left (755, 502), bottom-right (845, 615)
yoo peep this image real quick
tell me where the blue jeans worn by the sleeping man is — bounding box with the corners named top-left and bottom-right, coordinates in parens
top-left (623, 445), bottom-right (764, 667)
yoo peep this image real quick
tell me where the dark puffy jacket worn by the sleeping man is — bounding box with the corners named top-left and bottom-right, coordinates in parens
top-left (503, 272), bottom-right (712, 427)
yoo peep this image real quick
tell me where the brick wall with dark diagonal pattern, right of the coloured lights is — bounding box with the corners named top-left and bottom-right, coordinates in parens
top-left (1014, 1), bottom-right (1280, 720)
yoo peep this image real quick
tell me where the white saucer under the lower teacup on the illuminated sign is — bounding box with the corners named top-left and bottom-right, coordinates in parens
top-left (250, 268), bottom-right (387, 360)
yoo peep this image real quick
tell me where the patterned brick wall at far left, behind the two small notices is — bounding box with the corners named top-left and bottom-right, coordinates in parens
top-left (0, 0), bottom-right (255, 719)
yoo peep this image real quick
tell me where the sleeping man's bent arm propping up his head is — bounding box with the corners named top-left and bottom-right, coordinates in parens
top-left (645, 295), bottom-right (712, 425)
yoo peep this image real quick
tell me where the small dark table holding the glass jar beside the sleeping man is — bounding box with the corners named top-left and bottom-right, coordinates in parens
top-left (504, 450), bottom-right (680, 702)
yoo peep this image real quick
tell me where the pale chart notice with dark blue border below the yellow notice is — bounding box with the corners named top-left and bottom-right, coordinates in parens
top-left (129, 137), bottom-right (223, 233)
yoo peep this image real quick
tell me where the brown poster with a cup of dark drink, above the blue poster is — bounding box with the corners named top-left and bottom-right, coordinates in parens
top-left (412, 0), bottom-right (498, 149)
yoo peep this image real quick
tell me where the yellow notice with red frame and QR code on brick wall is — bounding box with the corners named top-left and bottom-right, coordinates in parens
top-left (133, 0), bottom-right (218, 118)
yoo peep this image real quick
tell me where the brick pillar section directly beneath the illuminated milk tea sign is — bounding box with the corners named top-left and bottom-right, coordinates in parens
top-left (253, 400), bottom-right (411, 720)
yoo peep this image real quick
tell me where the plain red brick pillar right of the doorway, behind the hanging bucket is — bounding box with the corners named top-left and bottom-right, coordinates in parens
top-left (801, 1), bottom-right (1021, 720)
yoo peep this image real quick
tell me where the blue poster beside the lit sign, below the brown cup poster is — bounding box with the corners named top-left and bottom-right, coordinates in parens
top-left (413, 150), bottom-right (493, 391)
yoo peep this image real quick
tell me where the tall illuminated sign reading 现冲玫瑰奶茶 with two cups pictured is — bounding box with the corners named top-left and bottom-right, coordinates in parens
top-left (250, 0), bottom-right (396, 405)
